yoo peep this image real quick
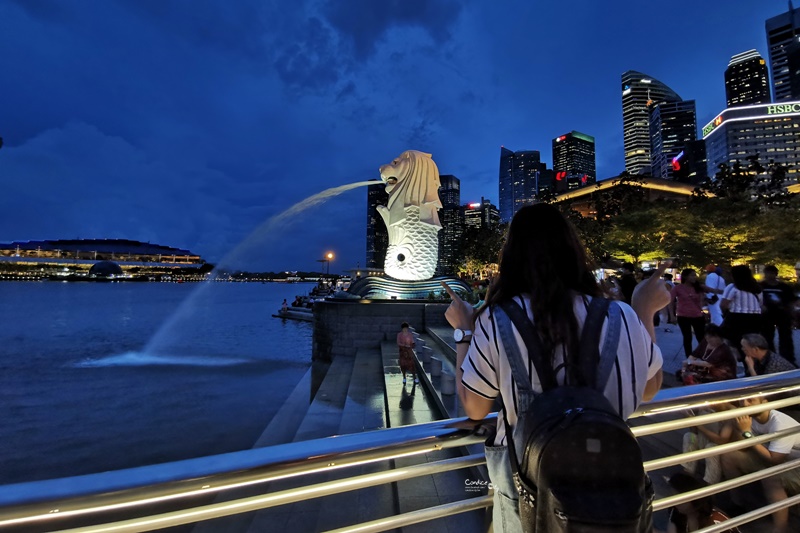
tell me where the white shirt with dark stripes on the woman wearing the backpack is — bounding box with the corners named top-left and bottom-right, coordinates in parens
top-left (461, 296), bottom-right (663, 445)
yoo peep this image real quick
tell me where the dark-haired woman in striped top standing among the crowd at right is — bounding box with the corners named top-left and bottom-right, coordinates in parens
top-left (719, 265), bottom-right (764, 356)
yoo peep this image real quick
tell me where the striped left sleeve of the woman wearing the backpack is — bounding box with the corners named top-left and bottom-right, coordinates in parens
top-left (461, 312), bottom-right (500, 400)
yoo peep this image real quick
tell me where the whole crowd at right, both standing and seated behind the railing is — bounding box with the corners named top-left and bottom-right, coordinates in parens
top-left (612, 262), bottom-right (800, 532)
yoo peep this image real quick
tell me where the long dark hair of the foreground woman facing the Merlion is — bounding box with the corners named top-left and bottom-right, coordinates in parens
top-left (486, 204), bottom-right (600, 354)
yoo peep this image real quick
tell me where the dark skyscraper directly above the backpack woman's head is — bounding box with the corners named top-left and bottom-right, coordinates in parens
top-left (500, 147), bottom-right (541, 222)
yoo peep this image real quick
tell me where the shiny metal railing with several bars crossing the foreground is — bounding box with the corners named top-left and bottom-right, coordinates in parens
top-left (0, 370), bottom-right (800, 533)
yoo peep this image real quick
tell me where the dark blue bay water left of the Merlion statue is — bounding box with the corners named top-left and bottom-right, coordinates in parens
top-left (0, 282), bottom-right (311, 484)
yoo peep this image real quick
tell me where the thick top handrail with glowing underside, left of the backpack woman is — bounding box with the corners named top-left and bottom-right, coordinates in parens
top-left (0, 415), bottom-right (496, 528)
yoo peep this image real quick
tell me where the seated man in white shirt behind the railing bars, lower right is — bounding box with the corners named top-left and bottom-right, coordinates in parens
top-left (722, 396), bottom-right (800, 533)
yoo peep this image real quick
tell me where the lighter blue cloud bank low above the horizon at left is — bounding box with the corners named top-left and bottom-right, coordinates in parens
top-left (0, 123), bottom-right (236, 260)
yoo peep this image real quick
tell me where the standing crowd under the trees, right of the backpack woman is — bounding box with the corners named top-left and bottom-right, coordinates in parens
top-left (605, 262), bottom-right (800, 385)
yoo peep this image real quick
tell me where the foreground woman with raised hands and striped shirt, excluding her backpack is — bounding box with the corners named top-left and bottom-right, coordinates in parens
top-left (442, 204), bottom-right (669, 531)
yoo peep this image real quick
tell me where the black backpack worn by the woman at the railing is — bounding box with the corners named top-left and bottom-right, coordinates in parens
top-left (500, 297), bottom-right (654, 533)
